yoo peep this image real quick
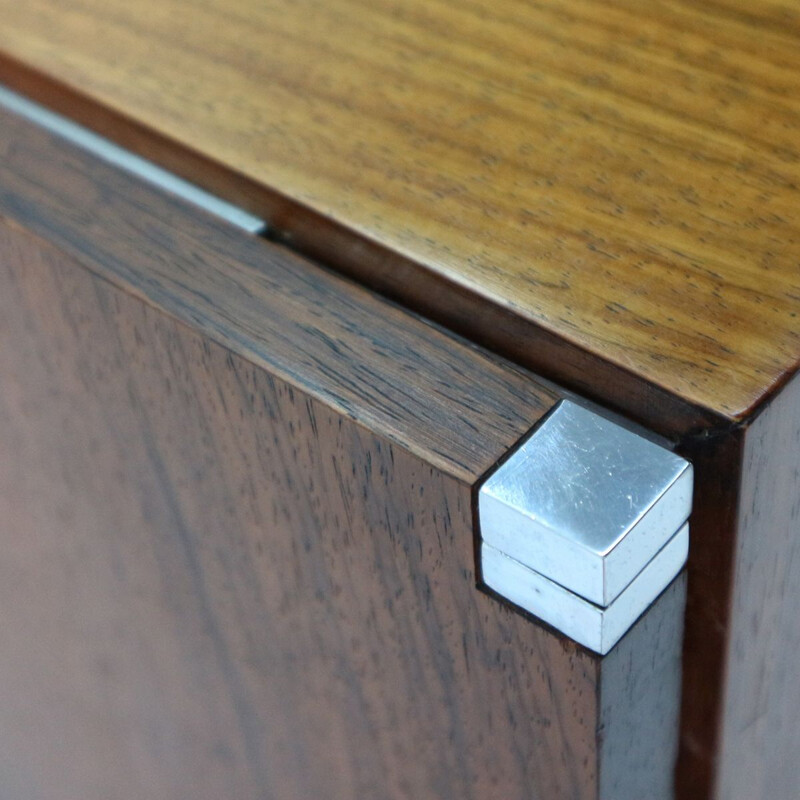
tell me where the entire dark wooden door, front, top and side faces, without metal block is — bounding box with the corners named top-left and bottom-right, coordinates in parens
top-left (0, 113), bottom-right (685, 800)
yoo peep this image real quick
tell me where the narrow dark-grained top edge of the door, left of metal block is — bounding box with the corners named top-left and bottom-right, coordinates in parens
top-left (0, 104), bottom-right (558, 483)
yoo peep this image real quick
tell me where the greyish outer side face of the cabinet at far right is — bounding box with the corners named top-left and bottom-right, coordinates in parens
top-left (717, 379), bottom-right (800, 800)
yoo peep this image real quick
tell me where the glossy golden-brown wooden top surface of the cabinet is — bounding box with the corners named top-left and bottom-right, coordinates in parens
top-left (0, 0), bottom-right (800, 419)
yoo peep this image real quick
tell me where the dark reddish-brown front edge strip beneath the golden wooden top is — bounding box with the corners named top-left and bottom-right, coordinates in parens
top-left (0, 57), bottom-right (732, 437)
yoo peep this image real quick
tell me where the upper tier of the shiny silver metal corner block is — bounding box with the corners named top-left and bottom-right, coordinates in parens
top-left (478, 400), bottom-right (693, 607)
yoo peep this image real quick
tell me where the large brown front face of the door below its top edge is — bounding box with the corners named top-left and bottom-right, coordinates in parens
top-left (0, 209), bottom-right (598, 800)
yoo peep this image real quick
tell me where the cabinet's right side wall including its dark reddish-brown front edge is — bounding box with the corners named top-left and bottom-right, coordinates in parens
top-left (678, 378), bottom-right (800, 800)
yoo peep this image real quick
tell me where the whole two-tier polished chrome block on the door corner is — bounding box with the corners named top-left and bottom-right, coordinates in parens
top-left (478, 400), bottom-right (693, 654)
